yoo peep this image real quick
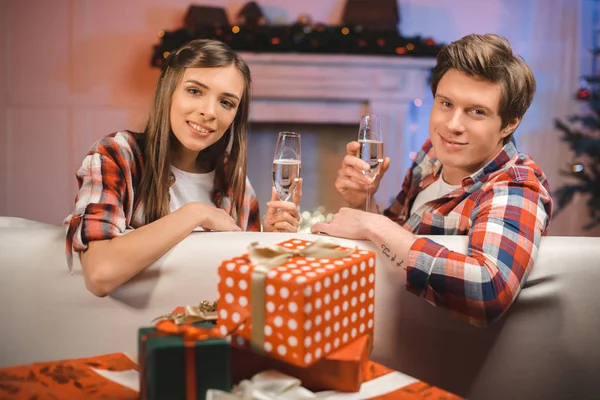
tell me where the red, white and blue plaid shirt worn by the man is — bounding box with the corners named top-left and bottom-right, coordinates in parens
top-left (384, 140), bottom-right (552, 326)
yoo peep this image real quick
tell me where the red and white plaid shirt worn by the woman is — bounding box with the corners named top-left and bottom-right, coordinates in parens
top-left (64, 131), bottom-right (261, 269)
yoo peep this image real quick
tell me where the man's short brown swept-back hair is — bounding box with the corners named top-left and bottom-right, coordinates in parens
top-left (431, 34), bottom-right (535, 133)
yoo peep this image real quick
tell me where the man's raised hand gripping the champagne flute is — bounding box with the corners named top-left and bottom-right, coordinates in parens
top-left (335, 142), bottom-right (390, 209)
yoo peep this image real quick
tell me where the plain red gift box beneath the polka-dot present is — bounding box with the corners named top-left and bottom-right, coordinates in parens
top-left (231, 335), bottom-right (370, 392)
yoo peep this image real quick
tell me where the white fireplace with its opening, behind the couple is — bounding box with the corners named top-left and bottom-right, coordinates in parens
top-left (242, 53), bottom-right (435, 217)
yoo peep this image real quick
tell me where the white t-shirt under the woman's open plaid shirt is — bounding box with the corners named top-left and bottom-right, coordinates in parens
top-left (169, 165), bottom-right (216, 212)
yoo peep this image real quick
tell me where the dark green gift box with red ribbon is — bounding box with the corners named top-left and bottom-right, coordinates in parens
top-left (138, 321), bottom-right (232, 400)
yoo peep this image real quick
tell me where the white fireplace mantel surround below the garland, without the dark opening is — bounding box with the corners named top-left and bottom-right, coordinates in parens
top-left (241, 53), bottom-right (435, 204)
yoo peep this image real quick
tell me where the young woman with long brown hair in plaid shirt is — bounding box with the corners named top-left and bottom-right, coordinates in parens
top-left (65, 40), bottom-right (302, 296)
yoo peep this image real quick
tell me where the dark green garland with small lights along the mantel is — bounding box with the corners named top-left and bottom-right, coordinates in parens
top-left (151, 23), bottom-right (442, 67)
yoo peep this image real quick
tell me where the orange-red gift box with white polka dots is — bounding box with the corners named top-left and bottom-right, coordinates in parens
top-left (217, 239), bottom-right (375, 366)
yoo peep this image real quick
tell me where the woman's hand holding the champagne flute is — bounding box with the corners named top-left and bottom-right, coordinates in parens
top-left (263, 178), bottom-right (302, 232)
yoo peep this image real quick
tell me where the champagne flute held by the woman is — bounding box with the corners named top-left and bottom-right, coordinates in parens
top-left (273, 132), bottom-right (301, 201)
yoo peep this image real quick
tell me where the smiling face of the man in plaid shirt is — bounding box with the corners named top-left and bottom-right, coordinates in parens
top-left (429, 69), bottom-right (519, 185)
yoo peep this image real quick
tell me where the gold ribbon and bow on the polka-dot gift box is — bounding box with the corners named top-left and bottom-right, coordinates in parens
top-left (248, 240), bottom-right (356, 354)
